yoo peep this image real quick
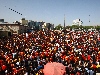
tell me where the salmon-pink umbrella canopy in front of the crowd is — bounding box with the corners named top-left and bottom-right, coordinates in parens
top-left (43, 62), bottom-right (65, 75)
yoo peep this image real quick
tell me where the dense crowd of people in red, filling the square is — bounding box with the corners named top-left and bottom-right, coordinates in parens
top-left (0, 30), bottom-right (100, 75)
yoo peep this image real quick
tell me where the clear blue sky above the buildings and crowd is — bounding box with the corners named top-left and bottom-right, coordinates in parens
top-left (0, 0), bottom-right (100, 26)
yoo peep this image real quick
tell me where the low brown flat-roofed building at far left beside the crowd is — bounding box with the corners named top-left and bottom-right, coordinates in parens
top-left (0, 23), bottom-right (30, 36)
